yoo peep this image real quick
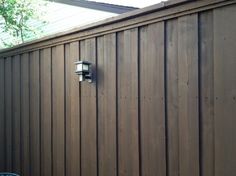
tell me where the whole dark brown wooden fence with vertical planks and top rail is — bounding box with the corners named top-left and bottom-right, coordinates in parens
top-left (0, 0), bottom-right (236, 176)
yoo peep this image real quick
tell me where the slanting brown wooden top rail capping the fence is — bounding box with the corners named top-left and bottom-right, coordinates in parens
top-left (0, 0), bottom-right (236, 58)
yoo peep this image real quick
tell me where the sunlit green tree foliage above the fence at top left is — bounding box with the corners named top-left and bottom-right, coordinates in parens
top-left (0, 0), bottom-right (46, 47)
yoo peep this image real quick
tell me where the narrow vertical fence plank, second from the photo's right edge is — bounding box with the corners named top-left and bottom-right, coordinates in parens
top-left (199, 11), bottom-right (215, 176)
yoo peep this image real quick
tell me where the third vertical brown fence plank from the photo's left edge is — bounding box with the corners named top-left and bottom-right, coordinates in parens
top-left (12, 55), bottom-right (21, 174)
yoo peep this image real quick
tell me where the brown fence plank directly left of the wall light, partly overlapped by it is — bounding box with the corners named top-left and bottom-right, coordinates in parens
top-left (65, 42), bottom-right (80, 176)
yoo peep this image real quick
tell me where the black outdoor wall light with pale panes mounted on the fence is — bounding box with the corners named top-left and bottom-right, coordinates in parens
top-left (75, 61), bottom-right (92, 83)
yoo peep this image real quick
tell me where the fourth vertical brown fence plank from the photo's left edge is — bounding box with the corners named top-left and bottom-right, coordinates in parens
top-left (20, 53), bottom-right (31, 176)
